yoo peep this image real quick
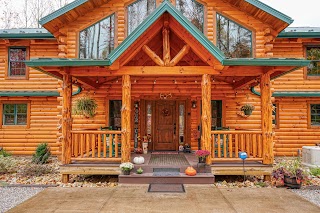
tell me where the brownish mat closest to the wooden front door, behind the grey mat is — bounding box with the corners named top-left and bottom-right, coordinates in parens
top-left (149, 154), bottom-right (189, 166)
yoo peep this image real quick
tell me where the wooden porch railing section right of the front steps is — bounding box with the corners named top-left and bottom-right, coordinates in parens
top-left (211, 130), bottom-right (263, 161)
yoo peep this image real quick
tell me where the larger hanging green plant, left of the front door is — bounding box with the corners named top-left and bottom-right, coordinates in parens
top-left (73, 96), bottom-right (98, 118)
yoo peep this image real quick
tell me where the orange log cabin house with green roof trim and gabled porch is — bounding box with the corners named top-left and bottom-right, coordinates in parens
top-left (0, 0), bottom-right (320, 181)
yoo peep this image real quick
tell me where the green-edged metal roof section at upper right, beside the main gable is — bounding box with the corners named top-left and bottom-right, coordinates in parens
top-left (277, 27), bottom-right (320, 38)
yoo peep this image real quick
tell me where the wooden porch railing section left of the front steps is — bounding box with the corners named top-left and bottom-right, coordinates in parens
top-left (71, 130), bottom-right (121, 162)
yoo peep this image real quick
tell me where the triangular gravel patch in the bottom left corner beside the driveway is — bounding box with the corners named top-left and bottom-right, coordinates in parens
top-left (0, 187), bottom-right (45, 213)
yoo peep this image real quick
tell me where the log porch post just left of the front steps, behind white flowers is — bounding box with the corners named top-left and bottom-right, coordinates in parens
top-left (121, 75), bottom-right (131, 162)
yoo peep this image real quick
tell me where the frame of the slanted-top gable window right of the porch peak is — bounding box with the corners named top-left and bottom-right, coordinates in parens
top-left (214, 11), bottom-right (255, 58)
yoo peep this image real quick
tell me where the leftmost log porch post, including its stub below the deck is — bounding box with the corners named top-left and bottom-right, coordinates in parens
top-left (62, 73), bottom-right (72, 183)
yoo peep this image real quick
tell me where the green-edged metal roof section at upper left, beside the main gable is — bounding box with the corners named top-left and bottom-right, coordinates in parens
top-left (0, 28), bottom-right (54, 39)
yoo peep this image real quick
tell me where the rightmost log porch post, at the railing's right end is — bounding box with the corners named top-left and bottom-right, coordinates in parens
top-left (260, 73), bottom-right (273, 164)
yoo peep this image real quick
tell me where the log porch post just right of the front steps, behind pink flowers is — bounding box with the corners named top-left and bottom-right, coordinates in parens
top-left (201, 74), bottom-right (212, 164)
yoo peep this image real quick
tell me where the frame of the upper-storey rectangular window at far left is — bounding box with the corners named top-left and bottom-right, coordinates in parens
top-left (5, 46), bottom-right (30, 80)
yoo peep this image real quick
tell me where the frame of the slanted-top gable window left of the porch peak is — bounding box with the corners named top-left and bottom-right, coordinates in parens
top-left (76, 12), bottom-right (118, 60)
